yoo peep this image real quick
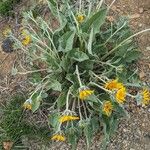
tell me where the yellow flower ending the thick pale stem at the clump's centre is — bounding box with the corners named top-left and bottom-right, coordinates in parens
top-left (79, 89), bottom-right (94, 100)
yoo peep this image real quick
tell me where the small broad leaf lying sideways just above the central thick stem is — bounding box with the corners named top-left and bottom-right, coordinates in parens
top-left (68, 49), bottom-right (89, 62)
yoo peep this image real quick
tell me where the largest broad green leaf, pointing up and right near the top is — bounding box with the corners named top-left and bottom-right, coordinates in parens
top-left (82, 9), bottom-right (107, 34)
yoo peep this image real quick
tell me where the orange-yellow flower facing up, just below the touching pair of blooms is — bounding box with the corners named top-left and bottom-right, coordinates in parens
top-left (102, 101), bottom-right (113, 116)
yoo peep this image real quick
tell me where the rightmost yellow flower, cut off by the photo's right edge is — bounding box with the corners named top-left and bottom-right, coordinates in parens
top-left (142, 89), bottom-right (150, 106)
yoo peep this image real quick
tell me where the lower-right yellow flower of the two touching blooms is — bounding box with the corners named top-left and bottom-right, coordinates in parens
top-left (116, 87), bottom-right (126, 104)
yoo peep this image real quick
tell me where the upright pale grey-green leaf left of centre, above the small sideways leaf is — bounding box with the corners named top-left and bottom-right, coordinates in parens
top-left (58, 31), bottom-right (75, 52)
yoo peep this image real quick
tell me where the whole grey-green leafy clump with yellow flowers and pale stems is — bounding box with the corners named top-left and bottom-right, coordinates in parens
top-left (14, 0), bottom-right (149, 149)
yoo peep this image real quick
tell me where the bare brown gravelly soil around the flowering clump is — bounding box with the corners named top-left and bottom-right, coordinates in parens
top-left (0, 0), bottom-right (150, 150)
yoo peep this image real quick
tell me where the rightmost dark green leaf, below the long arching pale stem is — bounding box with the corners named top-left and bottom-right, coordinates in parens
top-left (125, 50), bottom-right (141, 63)
